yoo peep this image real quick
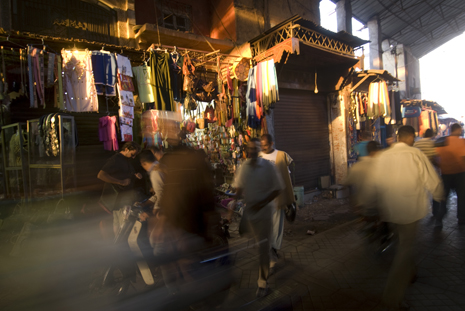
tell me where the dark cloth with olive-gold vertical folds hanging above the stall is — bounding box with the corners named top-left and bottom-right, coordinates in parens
top-left (150, 51), bottom-right (174, 111)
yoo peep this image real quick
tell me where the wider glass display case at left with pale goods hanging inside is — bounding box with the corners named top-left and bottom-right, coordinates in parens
top-left (27, 114), bottom-right (76, 197)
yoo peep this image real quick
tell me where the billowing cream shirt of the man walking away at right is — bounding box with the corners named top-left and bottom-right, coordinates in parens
top-left (366, 142), bottom-right (444, 224)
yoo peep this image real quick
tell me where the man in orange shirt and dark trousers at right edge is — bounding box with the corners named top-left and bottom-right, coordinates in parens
top-left (436, 123), bottom-right (465, 226)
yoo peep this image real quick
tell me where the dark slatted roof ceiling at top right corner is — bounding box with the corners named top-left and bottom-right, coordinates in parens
top-left (331, 0), bottom-right (465, 58)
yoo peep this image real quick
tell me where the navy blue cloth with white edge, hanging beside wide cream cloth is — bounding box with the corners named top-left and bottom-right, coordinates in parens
top-left (92, 51), bottom-right (117, 96)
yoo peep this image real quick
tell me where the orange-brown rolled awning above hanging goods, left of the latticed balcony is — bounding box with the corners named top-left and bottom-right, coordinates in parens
top-left (136, 24), bottom-right (234, 53)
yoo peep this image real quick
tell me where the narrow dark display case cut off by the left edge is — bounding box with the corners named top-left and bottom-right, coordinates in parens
top-left (1, 123), bottom-right (29, 200)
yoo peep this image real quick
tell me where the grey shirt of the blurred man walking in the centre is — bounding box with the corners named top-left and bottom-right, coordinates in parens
top-left (233, 158), bottom-right (284, 219)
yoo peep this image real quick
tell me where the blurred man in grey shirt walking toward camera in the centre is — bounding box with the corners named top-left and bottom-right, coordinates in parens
top-left (233, 138), bottom-right (284, 297)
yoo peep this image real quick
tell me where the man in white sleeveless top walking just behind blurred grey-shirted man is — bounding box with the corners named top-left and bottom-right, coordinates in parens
top-left (259, 134), bottom-right (295, 274)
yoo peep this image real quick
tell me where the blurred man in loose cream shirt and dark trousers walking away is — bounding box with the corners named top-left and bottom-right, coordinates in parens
top-left (367, 125), bottom-right (443, 308)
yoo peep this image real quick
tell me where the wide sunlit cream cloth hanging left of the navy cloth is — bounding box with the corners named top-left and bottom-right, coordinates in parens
top-left (61, 50), bottom-right (98, 112)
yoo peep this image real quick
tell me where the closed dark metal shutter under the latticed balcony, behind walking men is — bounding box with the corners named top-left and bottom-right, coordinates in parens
top-left (274, 89), bottom-right (331, 191)
